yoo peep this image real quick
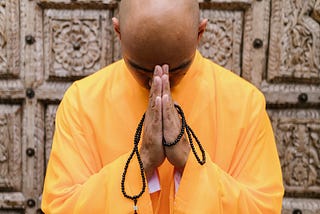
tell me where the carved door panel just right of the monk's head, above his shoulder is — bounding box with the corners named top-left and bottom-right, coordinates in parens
top-left (199, 9), bottom-right (243, 75)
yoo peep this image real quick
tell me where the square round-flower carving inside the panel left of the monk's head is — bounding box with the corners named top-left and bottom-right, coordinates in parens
top-left (51, 20), bottom-right (101, 76)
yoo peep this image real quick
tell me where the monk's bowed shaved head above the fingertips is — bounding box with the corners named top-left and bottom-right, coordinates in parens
top-left (116, 0), bottom-right (206, 88)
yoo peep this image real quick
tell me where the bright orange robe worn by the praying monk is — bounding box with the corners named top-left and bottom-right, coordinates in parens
top-left (42, 52), bottom-right (284, 214)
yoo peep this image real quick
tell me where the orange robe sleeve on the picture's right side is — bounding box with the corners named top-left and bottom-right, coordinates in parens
top-left (174, 93), bottom-right (284, 214)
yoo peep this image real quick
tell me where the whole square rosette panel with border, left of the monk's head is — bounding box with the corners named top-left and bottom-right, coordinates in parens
top-left (43, 9), bottom-right (112, 81)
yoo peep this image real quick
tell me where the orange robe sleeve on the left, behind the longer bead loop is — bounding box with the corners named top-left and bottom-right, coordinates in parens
top-left (41, 85), bottom-right (152, 214)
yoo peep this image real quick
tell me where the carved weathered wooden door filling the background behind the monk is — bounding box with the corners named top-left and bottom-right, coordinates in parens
top-left (0, 0), bottom-right (320, 213)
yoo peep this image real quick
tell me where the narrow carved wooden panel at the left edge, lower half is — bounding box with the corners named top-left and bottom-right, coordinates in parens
top-left (0, 105), bottom-right (21, 191)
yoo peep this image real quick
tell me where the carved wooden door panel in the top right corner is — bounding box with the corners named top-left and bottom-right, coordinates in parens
top-left (268, 0), bottom-right (320, 83)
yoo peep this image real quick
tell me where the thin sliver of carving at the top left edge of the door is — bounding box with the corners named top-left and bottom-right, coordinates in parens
top-left (0, 1), bottom-right (7, 73)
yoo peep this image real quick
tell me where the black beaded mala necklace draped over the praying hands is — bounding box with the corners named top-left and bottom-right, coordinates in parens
top-left (121, 104), bottom-right (206, 214)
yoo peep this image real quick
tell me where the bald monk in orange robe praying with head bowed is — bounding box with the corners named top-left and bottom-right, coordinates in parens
top-left (42, 0), bottom-right (284, 214)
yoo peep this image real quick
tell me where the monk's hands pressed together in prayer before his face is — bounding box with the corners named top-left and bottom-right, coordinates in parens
top-left (140, 65), bottom-right (190, 178)
